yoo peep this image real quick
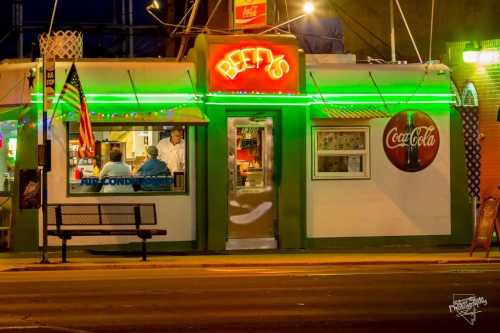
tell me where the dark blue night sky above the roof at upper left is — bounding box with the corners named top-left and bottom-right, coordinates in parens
top-left (0, 0), bottom-right (202, 59)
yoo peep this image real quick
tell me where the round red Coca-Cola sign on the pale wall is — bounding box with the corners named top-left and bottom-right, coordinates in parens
top-left (384, 110), bottom-right (439, 172)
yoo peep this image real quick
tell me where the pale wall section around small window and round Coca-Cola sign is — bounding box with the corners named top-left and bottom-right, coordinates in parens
top-left (307, 112), bottom-right (451, 238)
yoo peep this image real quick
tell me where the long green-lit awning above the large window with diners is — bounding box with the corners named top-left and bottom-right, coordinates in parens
top-left (59, 104), bottom-right (208, 125)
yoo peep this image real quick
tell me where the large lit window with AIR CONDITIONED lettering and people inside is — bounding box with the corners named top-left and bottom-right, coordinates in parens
top-left (68, 123), bottom-right (187, 195)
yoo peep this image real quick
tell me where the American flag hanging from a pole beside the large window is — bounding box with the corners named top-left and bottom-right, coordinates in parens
top-left (61, 64), bottom-right (95, 158)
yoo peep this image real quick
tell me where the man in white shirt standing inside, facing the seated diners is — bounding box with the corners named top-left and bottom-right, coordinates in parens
top-left (156, 127), bottom-right (186, 174)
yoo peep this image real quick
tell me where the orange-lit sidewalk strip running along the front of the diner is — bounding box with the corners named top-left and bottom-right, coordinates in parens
top-left (0, 247), bottom-right (500, 272)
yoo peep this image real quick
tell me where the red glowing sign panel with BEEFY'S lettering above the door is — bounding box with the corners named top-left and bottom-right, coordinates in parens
top-left (207, 40), bottom-right (299, 94)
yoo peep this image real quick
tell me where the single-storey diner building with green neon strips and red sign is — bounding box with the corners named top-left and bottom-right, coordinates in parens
top-left (0, 35), bottom-right (473, 252)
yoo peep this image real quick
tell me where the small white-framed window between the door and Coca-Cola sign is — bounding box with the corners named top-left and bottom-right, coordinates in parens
top-left (312, 127), bottom-right (370, 179)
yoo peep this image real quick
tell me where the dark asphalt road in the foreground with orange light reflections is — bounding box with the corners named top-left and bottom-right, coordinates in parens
top-left (0, 264), bottom-right (500, 333)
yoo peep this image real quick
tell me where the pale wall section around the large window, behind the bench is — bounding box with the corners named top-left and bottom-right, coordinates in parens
top-left (39, 121), bottom-right (196, 245)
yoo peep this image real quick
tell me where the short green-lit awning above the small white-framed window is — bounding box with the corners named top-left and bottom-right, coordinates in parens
top-left (311, 104), bottom-right (390, 119)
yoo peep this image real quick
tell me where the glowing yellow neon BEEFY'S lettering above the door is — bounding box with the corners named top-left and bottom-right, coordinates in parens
top-left (215, 47), bottom-right (290, 80)
